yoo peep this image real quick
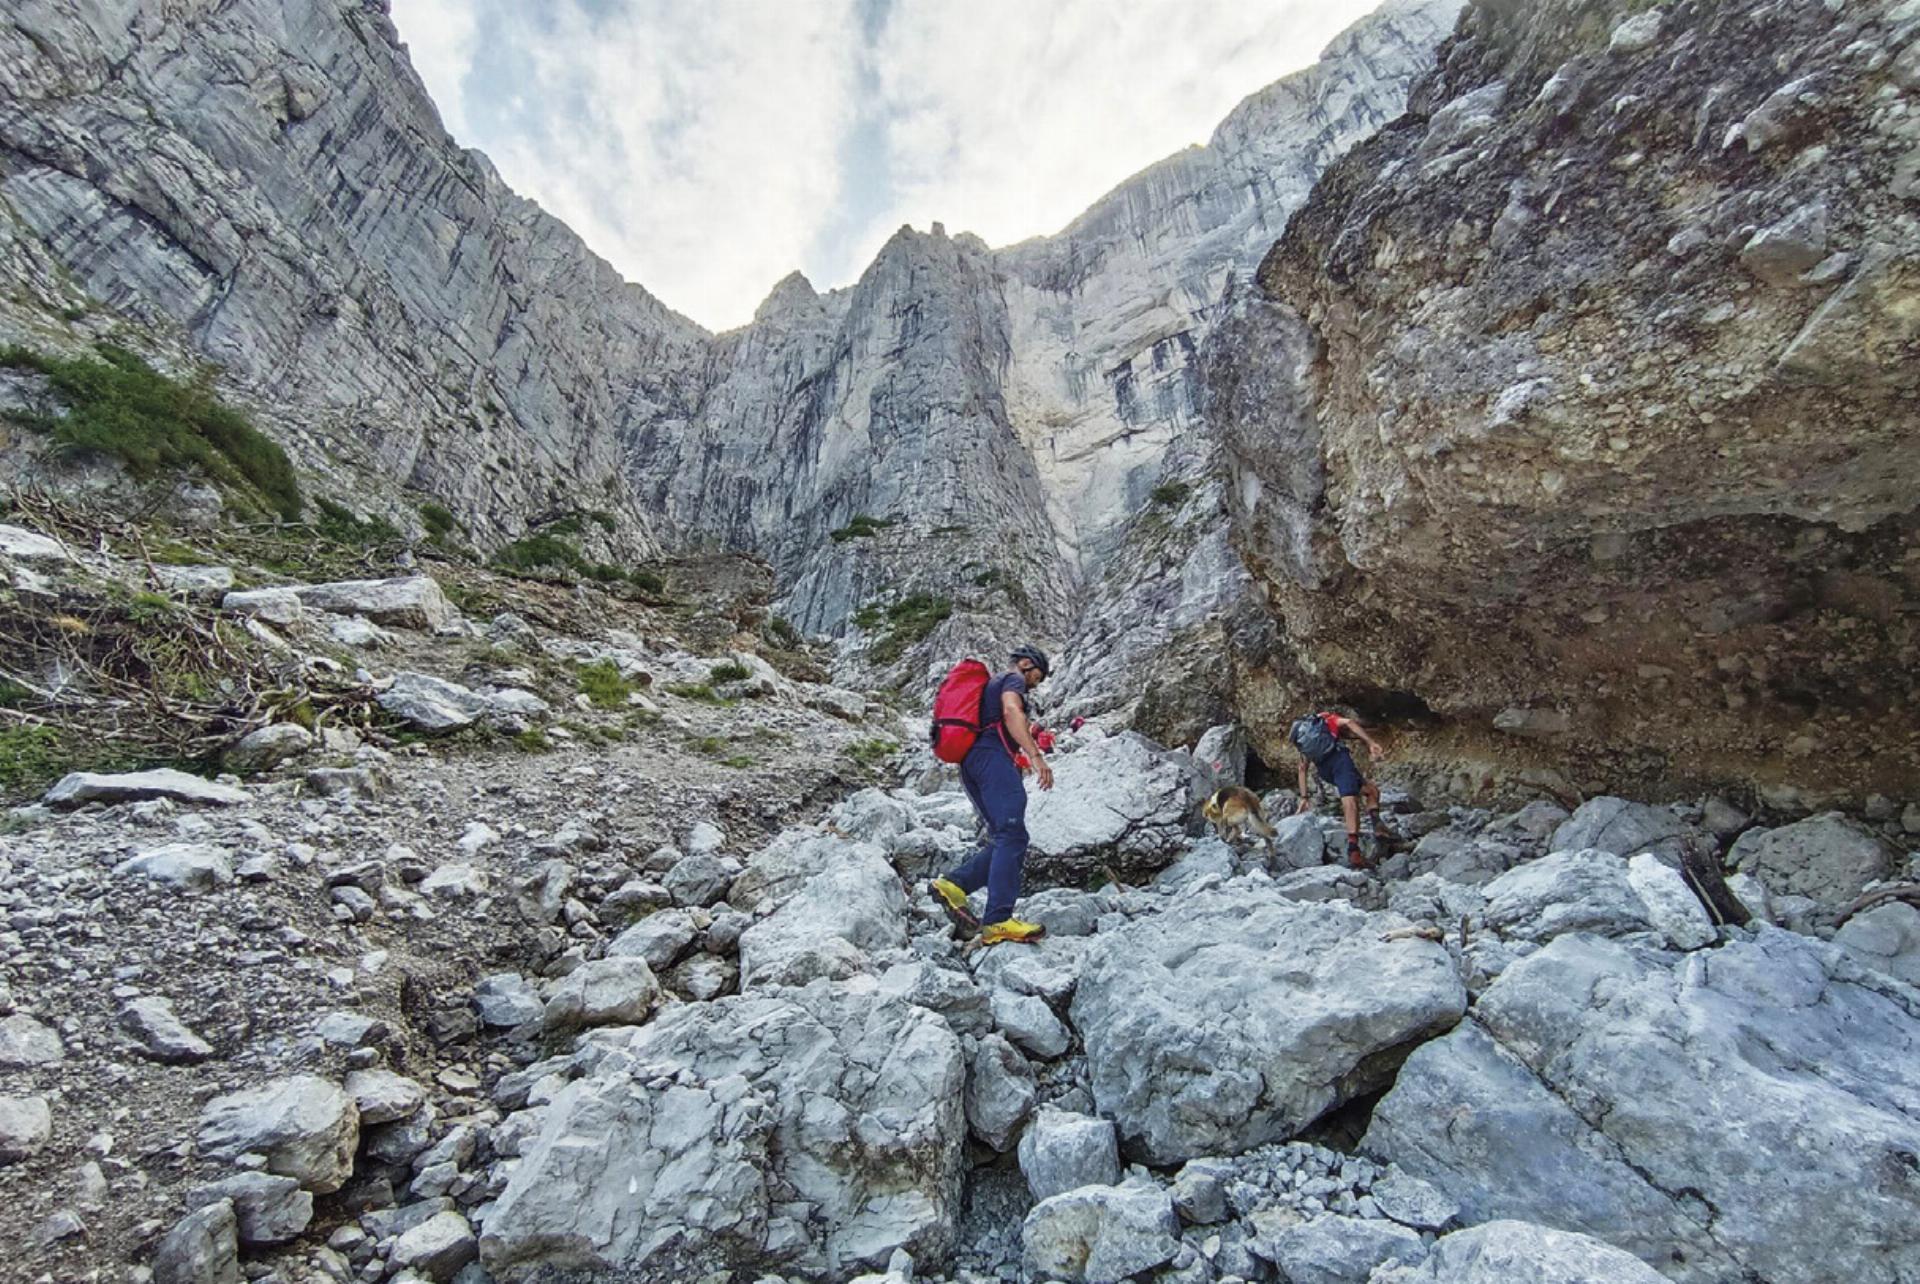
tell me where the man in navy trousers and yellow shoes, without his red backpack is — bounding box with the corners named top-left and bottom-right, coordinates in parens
top-left (929, 647), bottom-right (1054, 944)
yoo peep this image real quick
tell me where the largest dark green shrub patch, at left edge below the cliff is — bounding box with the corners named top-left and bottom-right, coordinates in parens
top-left (0, 344), bottom-right (301, 522)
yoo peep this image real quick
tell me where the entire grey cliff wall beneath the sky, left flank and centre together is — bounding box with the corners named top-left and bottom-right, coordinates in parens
top-left (0, 0), bottom-right (1463, 702)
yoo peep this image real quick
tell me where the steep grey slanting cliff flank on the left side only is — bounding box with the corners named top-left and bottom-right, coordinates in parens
top-left (0, 0), bottom-right (707, 551)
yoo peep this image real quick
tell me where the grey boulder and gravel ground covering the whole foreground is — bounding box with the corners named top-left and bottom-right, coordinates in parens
top-left (0, 618), bottom-right (1920, 1284)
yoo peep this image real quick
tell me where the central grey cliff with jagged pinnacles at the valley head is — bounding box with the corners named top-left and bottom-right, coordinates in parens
top-left (634, 0), bottom-right (1461, 694)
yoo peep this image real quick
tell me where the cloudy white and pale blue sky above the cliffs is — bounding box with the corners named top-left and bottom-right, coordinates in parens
top-left (394, 0), bottom-right (1375, 328)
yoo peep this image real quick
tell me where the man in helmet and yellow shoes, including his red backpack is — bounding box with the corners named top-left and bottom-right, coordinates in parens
top-left (927, 647), bottom-right (1054, 944)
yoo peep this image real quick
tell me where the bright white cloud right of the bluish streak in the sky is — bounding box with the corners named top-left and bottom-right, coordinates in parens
top-left (879, 0), bottom-right (1373, 246)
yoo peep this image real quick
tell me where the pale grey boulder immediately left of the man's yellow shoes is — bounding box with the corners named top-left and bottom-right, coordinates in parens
top-left (739, 843), bottom-right (906, 990)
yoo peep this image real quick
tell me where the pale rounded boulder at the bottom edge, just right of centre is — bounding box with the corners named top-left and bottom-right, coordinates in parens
top-left (1020, 1182), bottom-right (1181, 1284)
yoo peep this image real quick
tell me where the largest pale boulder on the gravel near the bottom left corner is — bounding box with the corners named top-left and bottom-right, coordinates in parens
top-left (200, 1075), bottom-right (359, 1196)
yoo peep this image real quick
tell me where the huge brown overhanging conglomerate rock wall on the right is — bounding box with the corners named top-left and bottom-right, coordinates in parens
top-left (1208, 0), bottom-right (1920, 795)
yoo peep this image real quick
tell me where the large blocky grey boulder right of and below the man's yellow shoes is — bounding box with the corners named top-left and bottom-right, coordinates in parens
top-left (1073, 883), bottom-right (1467, 1163)
